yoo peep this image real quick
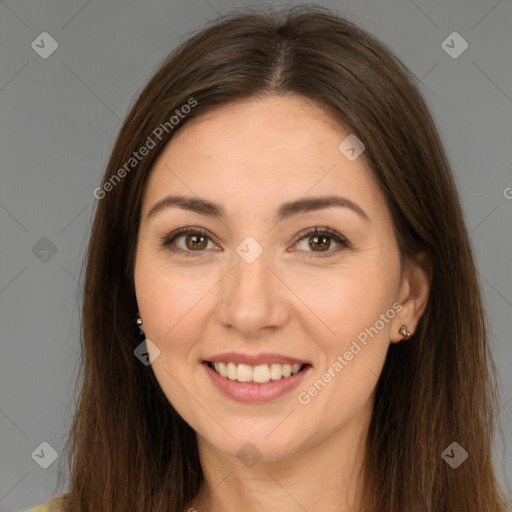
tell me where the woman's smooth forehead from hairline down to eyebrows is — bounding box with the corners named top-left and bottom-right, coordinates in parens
top-left (143, 96), bottom-right (385, 222)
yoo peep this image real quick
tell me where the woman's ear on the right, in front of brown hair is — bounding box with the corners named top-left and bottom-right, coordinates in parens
top-left (390, 253), bottom-right (432, 343)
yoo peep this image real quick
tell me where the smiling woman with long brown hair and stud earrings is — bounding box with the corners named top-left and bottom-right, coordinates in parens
top-left (28, 7), bottom-right (506, 512)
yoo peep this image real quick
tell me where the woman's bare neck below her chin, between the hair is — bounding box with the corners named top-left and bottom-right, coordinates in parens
top-left (192, 416), bottom-right (367, 512)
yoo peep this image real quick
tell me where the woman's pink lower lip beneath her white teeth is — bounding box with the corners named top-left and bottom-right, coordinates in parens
top-left (202, 363), bottom-right (311, 403)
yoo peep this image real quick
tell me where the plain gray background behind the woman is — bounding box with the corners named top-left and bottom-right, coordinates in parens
top-left (0, 0), bottom-right (512, 512)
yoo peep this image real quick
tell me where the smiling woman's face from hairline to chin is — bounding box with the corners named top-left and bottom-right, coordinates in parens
top-left (135, 96), bottom-right (422, 460)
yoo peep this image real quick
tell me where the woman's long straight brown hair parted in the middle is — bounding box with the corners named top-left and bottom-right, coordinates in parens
top-left (54, 5), bottom-right (506, 512)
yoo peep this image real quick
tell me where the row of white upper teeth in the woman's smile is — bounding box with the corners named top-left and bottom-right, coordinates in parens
top-left (209, 363), bottom-right (302, 384)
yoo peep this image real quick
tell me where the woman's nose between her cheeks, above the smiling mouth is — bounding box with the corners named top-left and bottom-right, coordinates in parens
top-left (218, 246), bottom-right (290, 339)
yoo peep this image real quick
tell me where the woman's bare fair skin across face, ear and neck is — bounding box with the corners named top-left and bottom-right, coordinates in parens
top-left (135, 96), bottom-right (429, 512)
